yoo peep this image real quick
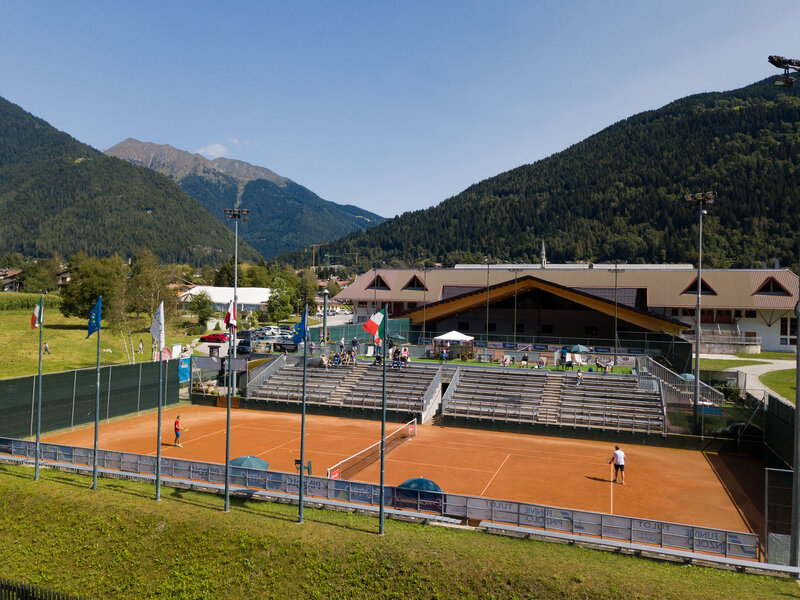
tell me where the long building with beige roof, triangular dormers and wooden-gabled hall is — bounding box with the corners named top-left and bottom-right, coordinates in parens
top-left (336, 261), bottom-right (798, 352)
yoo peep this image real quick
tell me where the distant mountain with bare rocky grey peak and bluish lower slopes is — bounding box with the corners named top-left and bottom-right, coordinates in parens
top-left (105, 138), bottom-right (385, 259)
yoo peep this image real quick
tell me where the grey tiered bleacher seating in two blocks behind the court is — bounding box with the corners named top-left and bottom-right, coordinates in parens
top-left (250, 361), bottom-right (665, 434)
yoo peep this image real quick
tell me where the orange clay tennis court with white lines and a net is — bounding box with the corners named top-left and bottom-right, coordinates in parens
top-left (42, 405), bottom-right (764, 533)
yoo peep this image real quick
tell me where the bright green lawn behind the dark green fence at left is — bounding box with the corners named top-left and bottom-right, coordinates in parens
top-left (0, 310), bottom-right (197, 378)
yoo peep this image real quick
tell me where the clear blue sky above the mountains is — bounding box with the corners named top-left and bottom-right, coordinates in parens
top-left (0, 0), bottom-right (800, 216)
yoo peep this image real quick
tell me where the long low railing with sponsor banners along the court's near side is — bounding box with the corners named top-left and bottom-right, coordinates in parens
top-left (0, 438), bottom-right (762, 561)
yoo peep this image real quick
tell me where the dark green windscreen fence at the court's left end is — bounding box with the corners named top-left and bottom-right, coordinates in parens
top-left (0, 360), bottom-right (178, 438)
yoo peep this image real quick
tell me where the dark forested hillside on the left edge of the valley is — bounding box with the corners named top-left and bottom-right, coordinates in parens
top-left (0, 98), bottom-right (259, 263)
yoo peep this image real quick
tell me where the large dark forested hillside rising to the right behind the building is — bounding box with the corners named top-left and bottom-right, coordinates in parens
top-left (286, 78), bottom-right (800, 268)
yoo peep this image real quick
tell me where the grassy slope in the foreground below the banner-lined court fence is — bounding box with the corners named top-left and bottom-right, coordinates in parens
top-left (0, 465), bottom-right (800, 600)
